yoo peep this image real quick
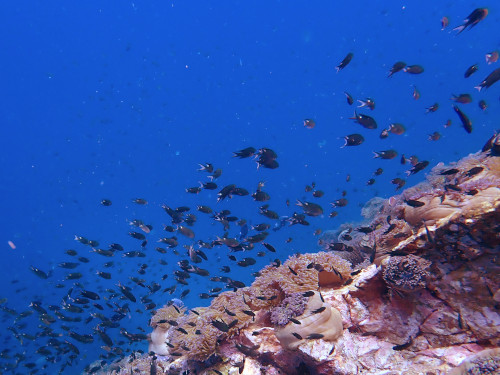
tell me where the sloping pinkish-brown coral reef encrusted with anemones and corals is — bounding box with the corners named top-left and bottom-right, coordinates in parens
top-left (99, 143), bottom-right (500, 375)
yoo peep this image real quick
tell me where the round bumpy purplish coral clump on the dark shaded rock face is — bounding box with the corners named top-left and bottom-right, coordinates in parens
top-left (383, 254), bottom-right (431, 292)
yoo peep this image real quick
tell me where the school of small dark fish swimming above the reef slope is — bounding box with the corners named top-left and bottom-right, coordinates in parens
top-left (0, 9), bottom-right (494, 374)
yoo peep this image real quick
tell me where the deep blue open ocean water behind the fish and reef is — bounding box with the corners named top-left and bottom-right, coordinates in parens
top-left (0, 0), bottom-right (500, 373)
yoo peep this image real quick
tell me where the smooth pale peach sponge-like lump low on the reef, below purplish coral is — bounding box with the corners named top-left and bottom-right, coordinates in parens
top-left (274, 291), bottom-right (343, 350)
